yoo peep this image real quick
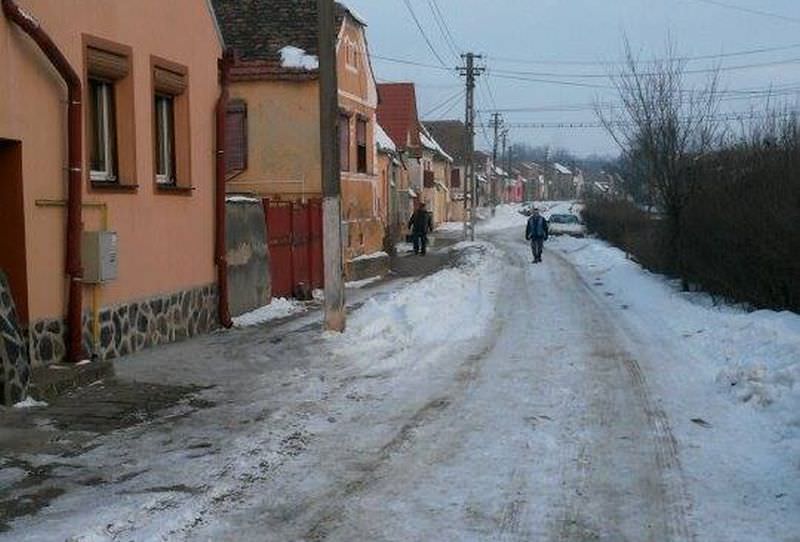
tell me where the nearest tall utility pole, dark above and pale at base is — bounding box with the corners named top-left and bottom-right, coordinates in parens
top-left (317, 0), bottom-right (346, 333)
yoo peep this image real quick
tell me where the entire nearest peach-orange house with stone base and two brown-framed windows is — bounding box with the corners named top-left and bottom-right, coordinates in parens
top-left (0, 0), bottom-right (222, 365)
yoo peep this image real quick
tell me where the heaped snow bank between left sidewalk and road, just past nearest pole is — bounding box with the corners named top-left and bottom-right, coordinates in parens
top-left (331, 243), bottom-right (502, 372)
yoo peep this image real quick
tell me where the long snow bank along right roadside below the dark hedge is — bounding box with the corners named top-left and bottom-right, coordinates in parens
top-left (551, 237), bottom-right (800, 438)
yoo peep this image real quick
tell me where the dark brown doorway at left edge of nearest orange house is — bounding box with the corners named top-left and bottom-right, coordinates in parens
top-left (0, 138), bottom-right (28, 326)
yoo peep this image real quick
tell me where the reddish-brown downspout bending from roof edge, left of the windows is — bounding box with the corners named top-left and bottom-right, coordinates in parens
top-left (2, 0), bottom-right (84, 363)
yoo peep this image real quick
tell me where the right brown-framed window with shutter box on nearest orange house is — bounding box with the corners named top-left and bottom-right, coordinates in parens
top-left (151, 57), bottom-right (192, 194)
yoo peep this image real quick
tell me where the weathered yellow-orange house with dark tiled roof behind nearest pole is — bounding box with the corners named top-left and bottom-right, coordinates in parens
top-left (214, 0), bottom-right (385, 277)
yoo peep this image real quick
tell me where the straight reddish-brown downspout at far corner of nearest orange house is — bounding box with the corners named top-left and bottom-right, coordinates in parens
top-left (214, 52), bottom-right (233, 328)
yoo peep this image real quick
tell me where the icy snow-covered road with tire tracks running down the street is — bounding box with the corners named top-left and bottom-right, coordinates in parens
top-left (0, 210), bottom-right (798, 542)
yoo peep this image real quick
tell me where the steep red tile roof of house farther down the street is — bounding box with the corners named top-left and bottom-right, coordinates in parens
top-left (378, 83), bottom-right (420, 150)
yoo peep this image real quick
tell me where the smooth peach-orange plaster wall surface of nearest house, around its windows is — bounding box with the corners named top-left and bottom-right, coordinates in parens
top-left (0, 0), bottom-right (221, 326)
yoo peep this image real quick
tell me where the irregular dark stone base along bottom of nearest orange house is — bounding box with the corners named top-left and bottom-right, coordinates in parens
top-left (29, 285), bottom-right (219, 366)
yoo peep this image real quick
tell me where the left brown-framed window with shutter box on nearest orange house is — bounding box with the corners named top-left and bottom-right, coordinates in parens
top-left (83, 36), bottom-right (136, 190)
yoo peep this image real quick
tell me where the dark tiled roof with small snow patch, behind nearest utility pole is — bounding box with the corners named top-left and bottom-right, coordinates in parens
top-left (212, 0), bottom-right (366, 80)
